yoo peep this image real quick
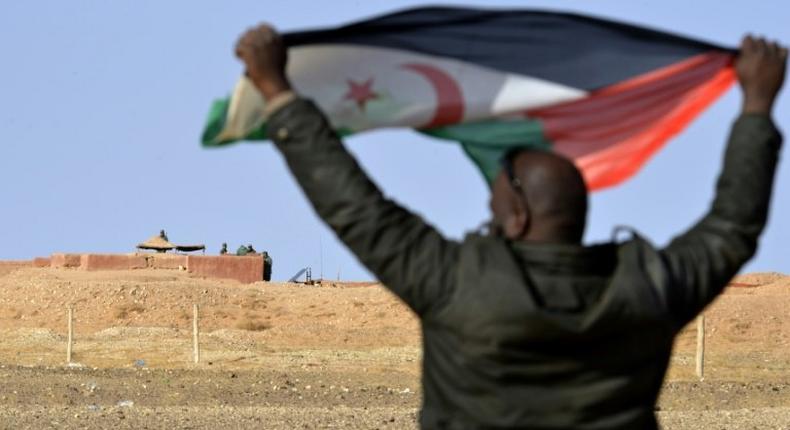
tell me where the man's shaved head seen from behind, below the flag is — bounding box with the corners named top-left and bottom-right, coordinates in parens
top-left (491, 149), bottom-right (587, 243)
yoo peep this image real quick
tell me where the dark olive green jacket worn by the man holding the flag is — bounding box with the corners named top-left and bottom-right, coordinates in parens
top-left (269, 99), bottom-right (781, 429)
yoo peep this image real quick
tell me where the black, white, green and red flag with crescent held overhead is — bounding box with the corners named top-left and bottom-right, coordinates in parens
top-left (202, 7), bottom-right (735, 190)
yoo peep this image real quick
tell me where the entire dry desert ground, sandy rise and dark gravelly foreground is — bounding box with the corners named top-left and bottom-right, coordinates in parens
top-left (0, 262), bottom-right (790, 429)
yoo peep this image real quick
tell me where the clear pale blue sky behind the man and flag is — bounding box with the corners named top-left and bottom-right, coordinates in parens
top-left (0, 0), bottom-right (790, 280)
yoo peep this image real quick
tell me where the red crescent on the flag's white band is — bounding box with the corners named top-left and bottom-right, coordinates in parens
top-left (401, 63), bottom-right (464, 128)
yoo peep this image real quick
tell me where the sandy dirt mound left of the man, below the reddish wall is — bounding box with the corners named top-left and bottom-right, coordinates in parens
top-left (0, 266), bottom-right (419, 348)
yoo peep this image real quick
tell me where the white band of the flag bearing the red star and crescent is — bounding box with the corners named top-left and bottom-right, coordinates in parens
top-left (220, 45), bottom-right (587, 139)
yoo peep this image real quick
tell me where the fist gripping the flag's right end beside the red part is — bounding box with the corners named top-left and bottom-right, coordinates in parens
top-left (735, 36), bottom-right (787, 114)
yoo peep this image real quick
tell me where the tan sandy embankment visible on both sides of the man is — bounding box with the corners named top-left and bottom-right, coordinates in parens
top-left (0, 262), bottom-right (790, 378)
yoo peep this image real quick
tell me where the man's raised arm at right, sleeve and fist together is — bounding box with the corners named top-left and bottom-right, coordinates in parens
top-left (662, 37), bottom-right (787, 325)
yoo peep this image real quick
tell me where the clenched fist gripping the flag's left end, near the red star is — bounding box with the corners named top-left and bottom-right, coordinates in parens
top-left (236, 24), bottom-right (291, 100)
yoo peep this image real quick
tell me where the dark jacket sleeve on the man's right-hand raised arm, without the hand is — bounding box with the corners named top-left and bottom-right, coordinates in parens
top-left (661, 114), bottom-right (782, 326)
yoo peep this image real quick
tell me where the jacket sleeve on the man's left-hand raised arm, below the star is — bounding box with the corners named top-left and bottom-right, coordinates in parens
top-left (268, 99), bottom-right (459, 315)
